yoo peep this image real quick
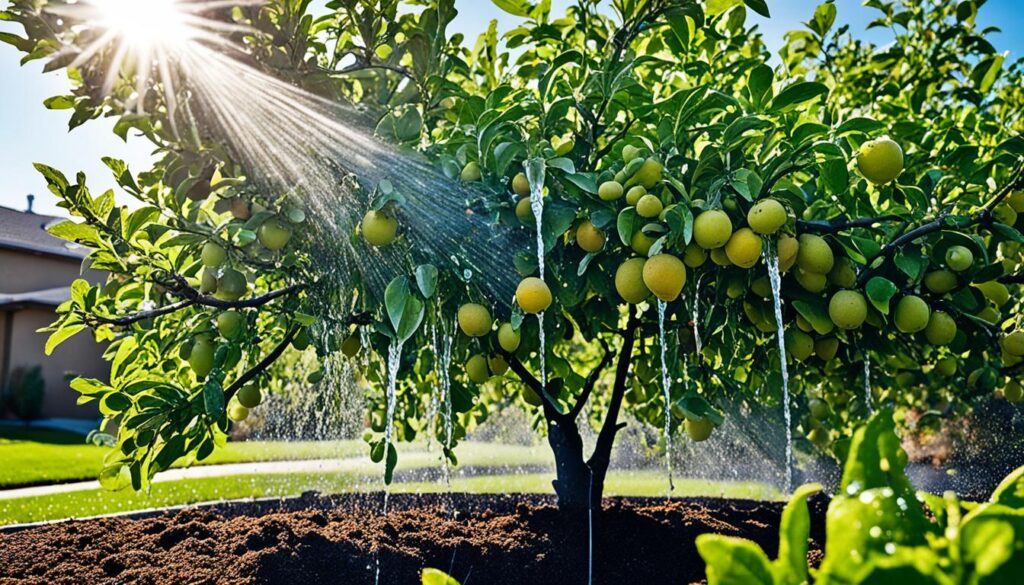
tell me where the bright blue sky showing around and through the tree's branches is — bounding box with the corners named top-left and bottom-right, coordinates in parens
top-left (0, 0), bottom-right (1024, 214)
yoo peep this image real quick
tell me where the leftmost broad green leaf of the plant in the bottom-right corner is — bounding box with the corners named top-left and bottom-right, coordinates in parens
top-left (696, 534), bottom-right (774, 585)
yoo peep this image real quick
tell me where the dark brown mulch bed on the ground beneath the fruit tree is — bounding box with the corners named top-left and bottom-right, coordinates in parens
top-left (0, 494), bottom-right (826, 585)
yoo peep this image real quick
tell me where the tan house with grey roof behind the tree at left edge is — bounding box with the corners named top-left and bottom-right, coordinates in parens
top-left (0, 195), bottom-right (110, 419)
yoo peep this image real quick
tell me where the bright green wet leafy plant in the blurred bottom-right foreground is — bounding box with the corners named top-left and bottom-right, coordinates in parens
top-left (696, 411), bottom-right (1024, 585)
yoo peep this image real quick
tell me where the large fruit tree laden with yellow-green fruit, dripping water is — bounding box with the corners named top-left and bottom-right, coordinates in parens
top-left (6, 0), bottom-right (1024, 508)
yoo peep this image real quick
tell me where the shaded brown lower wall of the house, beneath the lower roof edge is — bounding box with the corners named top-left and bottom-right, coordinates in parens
top-left (8, 308), bottom-right (109, 418)
